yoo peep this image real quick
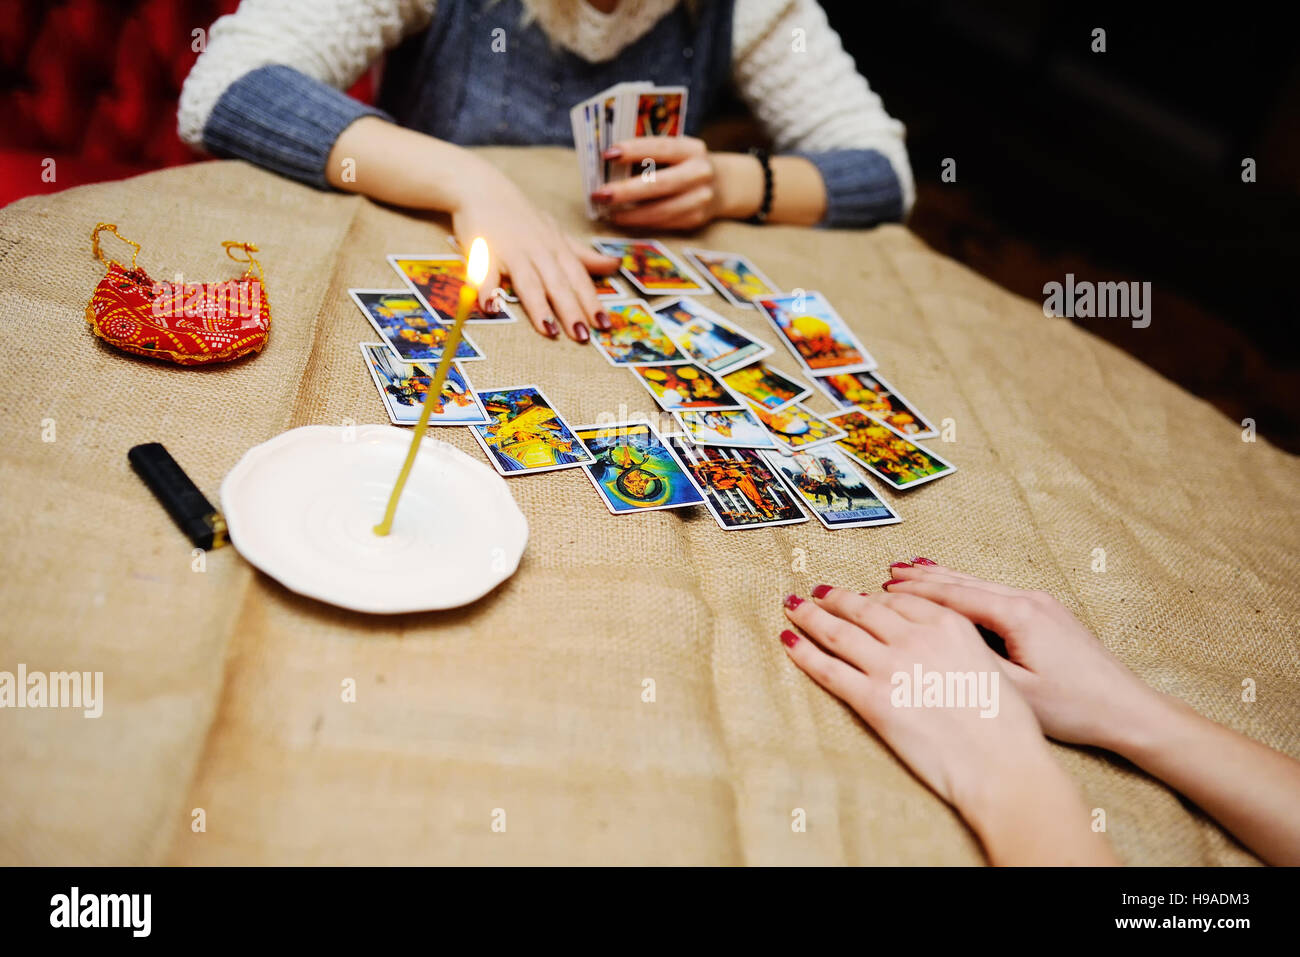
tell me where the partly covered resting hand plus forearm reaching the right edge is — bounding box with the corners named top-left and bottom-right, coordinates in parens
top-left (883, 559), bottom-right (1300, 866)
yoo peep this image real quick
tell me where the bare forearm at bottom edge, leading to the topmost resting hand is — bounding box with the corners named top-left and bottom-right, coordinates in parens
top-left (957, 744), bottom-right (1121, 866)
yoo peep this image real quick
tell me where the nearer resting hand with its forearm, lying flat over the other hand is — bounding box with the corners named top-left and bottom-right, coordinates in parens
top-left (781, 585), bottom-right (1117, 863)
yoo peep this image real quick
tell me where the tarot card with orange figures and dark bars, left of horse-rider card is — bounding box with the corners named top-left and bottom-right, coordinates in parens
top-left (668, 438), bottom-right (807, 532)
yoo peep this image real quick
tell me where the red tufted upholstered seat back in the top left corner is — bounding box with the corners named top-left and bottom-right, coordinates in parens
top-left (0, 0), bottom-right (369, 205)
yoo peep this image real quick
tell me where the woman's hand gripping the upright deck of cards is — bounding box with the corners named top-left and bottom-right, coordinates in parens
top-left (592, 137), bottom-right (763, 229)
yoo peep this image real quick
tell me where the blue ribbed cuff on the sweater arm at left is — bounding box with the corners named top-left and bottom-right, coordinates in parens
top-left (203, 64), bottom-right (389, 190)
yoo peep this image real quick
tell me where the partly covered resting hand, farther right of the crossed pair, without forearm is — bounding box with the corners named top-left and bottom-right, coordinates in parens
top-left (885, 558), bottom-right (1164, 750)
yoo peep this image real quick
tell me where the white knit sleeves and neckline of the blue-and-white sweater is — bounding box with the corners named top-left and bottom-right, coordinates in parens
top-left (179, 0), bottom-right (915, 213)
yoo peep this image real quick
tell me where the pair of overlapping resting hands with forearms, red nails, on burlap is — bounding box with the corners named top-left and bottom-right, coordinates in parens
top-left (781, 558), bottom-right (1300, 865)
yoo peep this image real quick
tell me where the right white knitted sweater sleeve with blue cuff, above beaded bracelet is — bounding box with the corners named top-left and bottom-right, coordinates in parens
top-left (732, 0), bottom-right (915, 226)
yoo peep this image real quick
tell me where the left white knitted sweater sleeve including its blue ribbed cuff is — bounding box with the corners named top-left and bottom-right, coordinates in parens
top-left (177, 0), bottom-right (436, 186)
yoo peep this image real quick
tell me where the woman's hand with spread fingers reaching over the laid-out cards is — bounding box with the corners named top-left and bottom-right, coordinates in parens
top-left (450, 163), bottom-right (619, 342)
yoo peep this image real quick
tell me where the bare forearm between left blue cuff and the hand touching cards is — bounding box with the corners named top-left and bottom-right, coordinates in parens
top-left (325, 116), bottom-right (486, 212)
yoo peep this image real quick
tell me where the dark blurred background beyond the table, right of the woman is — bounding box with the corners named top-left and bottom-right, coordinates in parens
top-left (822, 0), bottom-right (1300, 451)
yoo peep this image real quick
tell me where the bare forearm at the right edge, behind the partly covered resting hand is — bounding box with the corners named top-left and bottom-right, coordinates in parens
top-left (1112, 692), bottom-right (1300, 866)
